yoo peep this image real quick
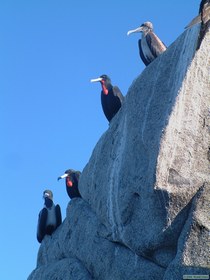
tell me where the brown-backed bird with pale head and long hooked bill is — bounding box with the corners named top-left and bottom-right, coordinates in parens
top-left (127, 21), bottom-right (166, 66)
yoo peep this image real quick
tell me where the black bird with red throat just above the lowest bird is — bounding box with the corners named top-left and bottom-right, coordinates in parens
top-left (58, 169), bottom-right (81, 198)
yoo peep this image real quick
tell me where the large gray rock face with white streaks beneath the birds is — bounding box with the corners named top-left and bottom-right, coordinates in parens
top-left (28, 25), bottom-right (210, 280)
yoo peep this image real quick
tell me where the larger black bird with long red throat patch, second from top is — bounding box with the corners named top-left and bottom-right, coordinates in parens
top-left (91, 75), bottom-right (124, 122)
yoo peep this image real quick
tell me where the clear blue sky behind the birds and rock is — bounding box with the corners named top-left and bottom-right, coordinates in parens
top-left (0, 0), bottom-right (200, 280)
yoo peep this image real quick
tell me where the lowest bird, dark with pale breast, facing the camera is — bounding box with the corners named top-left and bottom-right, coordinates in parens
top-left (37, 190), bottom-right (62, 243)
